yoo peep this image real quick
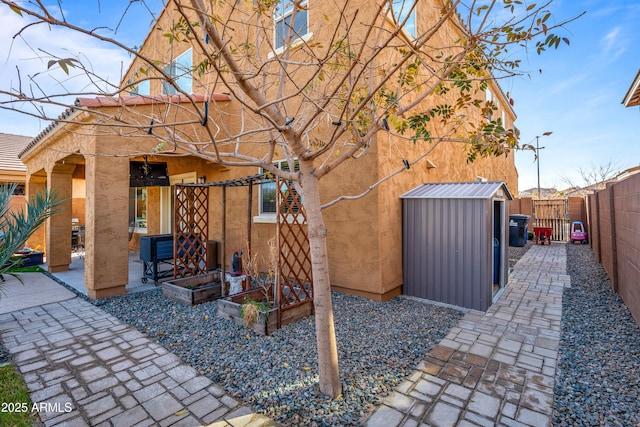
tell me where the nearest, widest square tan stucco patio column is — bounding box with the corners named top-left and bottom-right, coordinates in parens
top-left (84, 156), bottom-right (129, 299)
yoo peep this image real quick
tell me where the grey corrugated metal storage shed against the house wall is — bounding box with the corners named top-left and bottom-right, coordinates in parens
top-left (400, 182), bottom-right (512, 311)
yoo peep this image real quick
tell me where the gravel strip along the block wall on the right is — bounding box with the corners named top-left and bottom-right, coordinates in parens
top-left (553, 245), bottom-right (640, 426)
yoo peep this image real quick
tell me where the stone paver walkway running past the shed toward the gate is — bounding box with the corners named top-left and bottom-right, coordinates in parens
top-left (366, 243), bottom-right (570, 427)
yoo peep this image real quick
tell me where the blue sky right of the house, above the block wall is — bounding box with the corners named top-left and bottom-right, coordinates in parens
top-left (501, 0), bottom-right (640, 191)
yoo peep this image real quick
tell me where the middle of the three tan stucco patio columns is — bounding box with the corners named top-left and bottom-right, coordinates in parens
top-left (46, 163), bottom-right (75, 273)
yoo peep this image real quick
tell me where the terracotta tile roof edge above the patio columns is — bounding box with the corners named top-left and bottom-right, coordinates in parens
top-left (18, 93), bottom-right (231, 158)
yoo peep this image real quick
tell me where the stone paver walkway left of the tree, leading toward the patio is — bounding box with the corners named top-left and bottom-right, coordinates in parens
top-left (0, 280), bottom-right (277, 427)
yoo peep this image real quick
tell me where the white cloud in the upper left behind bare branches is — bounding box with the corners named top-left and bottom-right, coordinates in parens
top-left (0, 7), bottom-right (131, 135)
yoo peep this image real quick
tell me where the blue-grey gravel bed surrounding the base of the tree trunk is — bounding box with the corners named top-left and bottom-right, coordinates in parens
top-left (92, 290), bottom-right (462, 426)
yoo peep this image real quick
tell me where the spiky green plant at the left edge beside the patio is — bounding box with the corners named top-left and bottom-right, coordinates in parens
top-left (0, 184), bottom-right (63, 294)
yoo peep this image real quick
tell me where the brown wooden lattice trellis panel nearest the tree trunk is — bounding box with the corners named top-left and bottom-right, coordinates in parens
top-left (276, 178), bottom-right (313, 323)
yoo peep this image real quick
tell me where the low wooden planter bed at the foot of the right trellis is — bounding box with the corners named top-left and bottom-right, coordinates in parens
top-left (218, 289), bottom-right (313, 335)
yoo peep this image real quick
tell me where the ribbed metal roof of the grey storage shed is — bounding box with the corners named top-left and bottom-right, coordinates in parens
top-left (400, 181), bottom-right (513, 200)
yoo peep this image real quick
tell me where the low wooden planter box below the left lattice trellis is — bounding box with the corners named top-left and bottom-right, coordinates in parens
top-left (162, 272), bottom-right (222, 305)
